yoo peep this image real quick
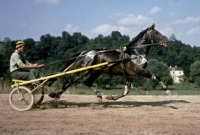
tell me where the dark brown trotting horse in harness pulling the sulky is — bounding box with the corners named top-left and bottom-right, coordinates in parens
top-left (49, 24), bottom-right (170, 102)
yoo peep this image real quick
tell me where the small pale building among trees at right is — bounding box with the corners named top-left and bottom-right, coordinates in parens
top-left (169, 66), bottom-right (184, 83)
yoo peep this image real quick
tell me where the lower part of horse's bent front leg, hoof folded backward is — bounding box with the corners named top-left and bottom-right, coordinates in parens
top-left (106, 79), bottom-right (133, 100)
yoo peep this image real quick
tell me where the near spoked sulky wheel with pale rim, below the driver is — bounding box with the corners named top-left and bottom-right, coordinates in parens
top-left (9, 86), bottom-right (34, 111)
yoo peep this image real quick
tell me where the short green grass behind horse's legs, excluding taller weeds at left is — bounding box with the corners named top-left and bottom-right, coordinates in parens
top-left (61, 85), bottom-right (200, 95)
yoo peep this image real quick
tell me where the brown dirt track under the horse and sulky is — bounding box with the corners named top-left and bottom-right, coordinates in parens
top-left (0, 94), bottom-right (200, 135)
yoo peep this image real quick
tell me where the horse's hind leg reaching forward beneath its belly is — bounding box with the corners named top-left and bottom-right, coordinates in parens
top-left (84, 72), bottom-right (102, 102)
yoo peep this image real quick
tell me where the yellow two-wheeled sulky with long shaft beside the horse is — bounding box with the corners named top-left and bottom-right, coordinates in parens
top-left (9, 62), bottom-right (108, 111)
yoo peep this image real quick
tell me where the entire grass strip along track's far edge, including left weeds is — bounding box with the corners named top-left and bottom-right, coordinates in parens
top-left (0, 81), bottom-right (200, 95)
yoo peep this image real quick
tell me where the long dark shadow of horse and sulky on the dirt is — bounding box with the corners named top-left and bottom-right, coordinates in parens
top-left (35, 100), bottom-right (190, 109)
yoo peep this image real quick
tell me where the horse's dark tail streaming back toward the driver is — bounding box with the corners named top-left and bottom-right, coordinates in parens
top-left (62, 50), bottom-right (88, 72)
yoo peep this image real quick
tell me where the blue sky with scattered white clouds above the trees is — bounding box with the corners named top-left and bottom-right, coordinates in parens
top-left (0, 0), bottom-right (200, 46)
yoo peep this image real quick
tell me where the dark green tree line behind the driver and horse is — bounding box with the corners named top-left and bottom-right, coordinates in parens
top-left (0, 31), bottom-right (200, 87)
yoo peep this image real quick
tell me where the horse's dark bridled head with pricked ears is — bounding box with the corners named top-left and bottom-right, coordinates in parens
top-left (146, 24), bottom-right (169, 47)
